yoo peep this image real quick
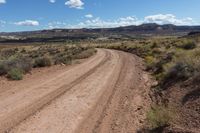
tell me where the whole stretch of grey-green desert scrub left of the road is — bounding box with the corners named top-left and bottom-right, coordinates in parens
top-left (0, 44), bottom-right (96, 80)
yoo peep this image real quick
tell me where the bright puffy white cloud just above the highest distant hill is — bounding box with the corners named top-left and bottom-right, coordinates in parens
top-left (144, 14), bottom-right (194, 25)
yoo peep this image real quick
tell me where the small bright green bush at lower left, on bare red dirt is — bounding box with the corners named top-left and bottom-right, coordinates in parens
top-left (8, 68), bottom-right (23, 80)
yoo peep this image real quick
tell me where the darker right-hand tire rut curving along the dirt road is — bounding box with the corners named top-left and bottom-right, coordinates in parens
top-left (76, 52), bottom-right (127, 133)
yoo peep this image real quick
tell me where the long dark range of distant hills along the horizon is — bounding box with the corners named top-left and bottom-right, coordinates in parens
top-left (0, 23), bottom-right (200, 43)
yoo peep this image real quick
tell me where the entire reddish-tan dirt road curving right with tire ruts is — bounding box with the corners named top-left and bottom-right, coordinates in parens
top-left (0, 49), bottom-right (149, 133)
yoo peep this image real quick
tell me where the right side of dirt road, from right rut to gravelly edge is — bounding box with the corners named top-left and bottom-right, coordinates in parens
top-left (76, 52), bottom-right (150, 133)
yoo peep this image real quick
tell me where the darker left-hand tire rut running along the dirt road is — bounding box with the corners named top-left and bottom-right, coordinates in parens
top-left (0, 50), bottom-right (110, 132)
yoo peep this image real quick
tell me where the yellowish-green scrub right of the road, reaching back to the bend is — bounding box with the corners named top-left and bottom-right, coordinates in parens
top-left (99, 38), bottom-right (200, 86)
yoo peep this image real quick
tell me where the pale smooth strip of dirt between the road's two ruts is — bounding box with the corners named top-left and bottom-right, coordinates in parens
top-left (11, 49), bottom-right (118, 133)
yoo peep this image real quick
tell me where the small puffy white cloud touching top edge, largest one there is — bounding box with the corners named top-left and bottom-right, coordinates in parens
top-left (65, 0), bottom-right (84, 9)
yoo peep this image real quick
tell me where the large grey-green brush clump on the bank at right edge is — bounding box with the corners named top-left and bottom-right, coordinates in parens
top-left (161, 49), bottom-right (200, 85)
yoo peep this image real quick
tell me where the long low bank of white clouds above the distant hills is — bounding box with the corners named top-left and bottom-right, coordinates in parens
top-left (45, 14), bottom-right (199, 28)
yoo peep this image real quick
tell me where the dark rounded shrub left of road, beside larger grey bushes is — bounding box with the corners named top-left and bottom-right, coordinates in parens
top-left (34, 57), bottom-right (52, 67)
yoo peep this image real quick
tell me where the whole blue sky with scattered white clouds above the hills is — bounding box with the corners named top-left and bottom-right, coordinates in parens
top-left (0, 0), bottom-right (200, 32)
